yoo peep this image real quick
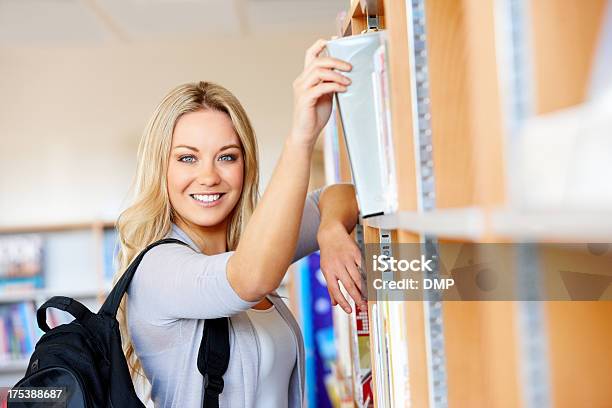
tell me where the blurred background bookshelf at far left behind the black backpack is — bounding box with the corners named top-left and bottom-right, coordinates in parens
top-left (0, 221), bottom-right (118, 386)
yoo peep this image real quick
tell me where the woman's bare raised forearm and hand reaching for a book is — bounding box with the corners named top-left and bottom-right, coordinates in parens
top-left (227, 40), bottom-right (351, 301)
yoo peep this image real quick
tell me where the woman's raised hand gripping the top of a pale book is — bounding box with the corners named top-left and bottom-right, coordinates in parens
top-left (291, 40), bottom-right (352, 147)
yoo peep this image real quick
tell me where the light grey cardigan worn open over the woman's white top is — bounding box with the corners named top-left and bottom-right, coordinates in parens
top-left (127, 190), bottom-right (321, 408)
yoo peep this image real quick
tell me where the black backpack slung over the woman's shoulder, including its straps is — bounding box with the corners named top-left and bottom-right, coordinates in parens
top-left (8, 238), bottom-right (229, 408)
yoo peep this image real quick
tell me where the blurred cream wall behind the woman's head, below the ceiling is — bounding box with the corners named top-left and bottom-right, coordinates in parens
top-left (0, 34), bottom-right (326, 226)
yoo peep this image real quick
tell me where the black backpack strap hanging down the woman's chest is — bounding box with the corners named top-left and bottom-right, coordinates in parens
top-left (198, 317), bottom-right (230, 408)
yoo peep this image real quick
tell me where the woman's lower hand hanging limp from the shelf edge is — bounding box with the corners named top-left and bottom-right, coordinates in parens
top-left (317, 223), bottom-right (367, 313)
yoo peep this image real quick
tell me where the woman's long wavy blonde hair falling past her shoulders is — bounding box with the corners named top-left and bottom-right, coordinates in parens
top-left (113, 82), bottom-right (259, 398)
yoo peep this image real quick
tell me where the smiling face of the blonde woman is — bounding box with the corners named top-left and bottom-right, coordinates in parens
top-left (167, 109), bottom-right (244, 228)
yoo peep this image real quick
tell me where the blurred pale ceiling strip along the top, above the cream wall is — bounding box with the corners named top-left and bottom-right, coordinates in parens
top-left (0, 0), bottom-right (349, 46)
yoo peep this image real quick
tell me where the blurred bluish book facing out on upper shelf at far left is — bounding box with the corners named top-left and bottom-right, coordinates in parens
top-left (0, 234), bottom-right (44, 293)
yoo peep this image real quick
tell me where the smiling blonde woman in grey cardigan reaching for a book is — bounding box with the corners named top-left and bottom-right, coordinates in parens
top-left (113, 40), bottom-right (365, 408)
